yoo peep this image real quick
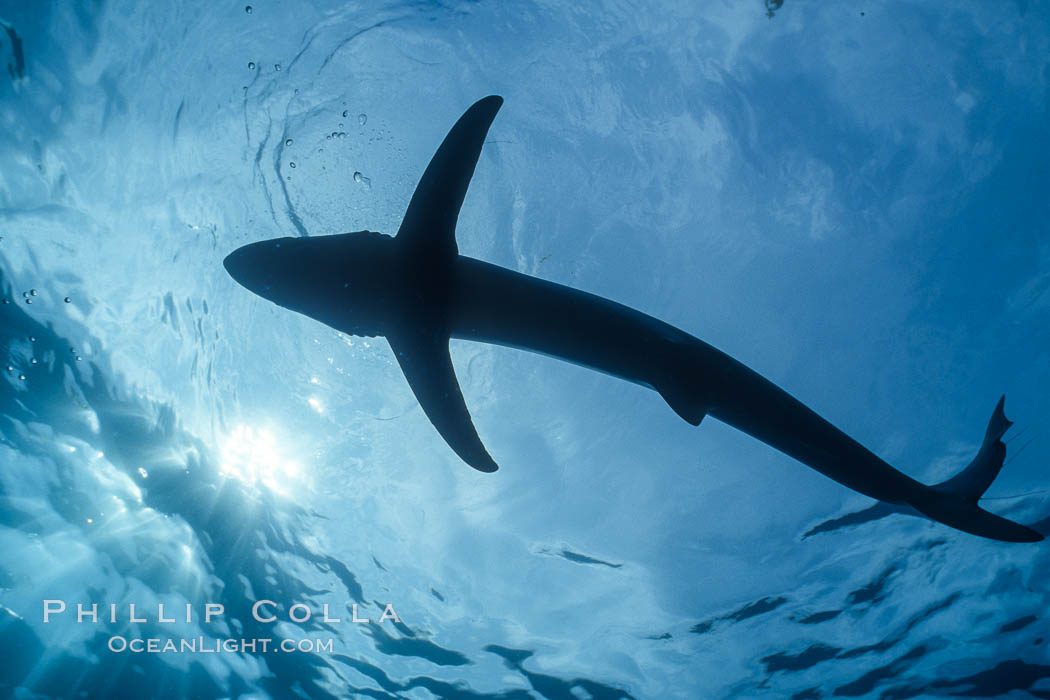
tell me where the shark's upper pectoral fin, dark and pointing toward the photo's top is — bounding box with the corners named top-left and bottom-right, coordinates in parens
top-left (397, 94), bottom-right (503, 259)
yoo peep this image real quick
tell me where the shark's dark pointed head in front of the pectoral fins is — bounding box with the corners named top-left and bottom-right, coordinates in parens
top-left (223, 231), bottom-right (394, 336)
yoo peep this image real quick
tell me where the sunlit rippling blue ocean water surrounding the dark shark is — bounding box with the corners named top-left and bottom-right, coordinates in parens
top-left (0, 0), bottom-right (1050, 700)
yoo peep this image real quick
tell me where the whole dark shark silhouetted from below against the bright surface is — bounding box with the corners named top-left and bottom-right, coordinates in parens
top-left (224, 96), bottom-right (1043, 542)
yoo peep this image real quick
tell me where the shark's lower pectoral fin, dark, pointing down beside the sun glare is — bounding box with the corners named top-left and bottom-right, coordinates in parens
top-left (389, 330), bottom-right (499, 471)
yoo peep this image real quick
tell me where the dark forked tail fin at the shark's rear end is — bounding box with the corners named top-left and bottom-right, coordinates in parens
top-left (908, 397), bottom-right (1043, 542)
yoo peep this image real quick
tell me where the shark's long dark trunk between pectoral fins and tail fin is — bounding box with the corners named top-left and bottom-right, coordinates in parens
top-left (448, 256), bottom-right (920, 503)
